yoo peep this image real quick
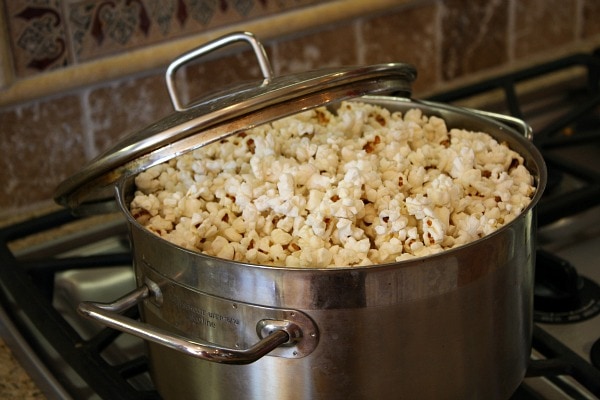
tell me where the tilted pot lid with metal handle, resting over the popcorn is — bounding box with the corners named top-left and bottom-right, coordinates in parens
top-left (54, 32), bottom-right (416, 214)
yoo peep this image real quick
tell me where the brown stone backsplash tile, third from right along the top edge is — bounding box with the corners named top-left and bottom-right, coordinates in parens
top-left (440, 0), bottom-right (509, 81)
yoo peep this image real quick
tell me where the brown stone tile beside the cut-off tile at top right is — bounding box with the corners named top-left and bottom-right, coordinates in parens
top-left (514, 0), bottom-right (577, 59)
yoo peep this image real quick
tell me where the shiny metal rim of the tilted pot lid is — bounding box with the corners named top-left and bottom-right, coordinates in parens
top-left (54, 76), bottom-right (410, 214)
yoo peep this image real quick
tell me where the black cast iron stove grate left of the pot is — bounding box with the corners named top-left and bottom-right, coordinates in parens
top-left (0, 210), bottom-right (159, 400)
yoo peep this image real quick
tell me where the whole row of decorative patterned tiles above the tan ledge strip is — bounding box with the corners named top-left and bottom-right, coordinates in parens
top-left (3, 0), bottom-right (331, 78)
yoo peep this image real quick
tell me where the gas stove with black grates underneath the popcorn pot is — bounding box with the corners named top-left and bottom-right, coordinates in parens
top-left (0, 54), bottom-right (600, 399)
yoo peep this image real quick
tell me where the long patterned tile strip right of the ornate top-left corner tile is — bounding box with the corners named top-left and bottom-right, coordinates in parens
top-left (67, 0), bottom-right (326, 62)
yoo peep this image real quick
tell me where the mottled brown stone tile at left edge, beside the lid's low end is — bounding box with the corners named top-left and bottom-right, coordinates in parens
top-left (0, 95), bottom-right (85, 208)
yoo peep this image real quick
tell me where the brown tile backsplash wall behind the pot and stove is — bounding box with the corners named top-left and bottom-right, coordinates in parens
top-left (0, 0), bottom-right (600, 213)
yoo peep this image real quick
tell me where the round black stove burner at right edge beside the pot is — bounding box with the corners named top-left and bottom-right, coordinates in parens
top-left (534, 249), bottom-right (600, 324)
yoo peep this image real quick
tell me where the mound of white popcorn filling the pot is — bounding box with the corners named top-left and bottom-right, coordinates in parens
top-left (130, 101), bottom-right (535, 268)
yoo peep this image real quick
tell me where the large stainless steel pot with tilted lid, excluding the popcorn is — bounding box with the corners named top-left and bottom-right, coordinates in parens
top-left (56, 33), bottom-right (546, 399)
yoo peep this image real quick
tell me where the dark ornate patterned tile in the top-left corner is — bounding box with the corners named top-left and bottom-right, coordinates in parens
top-left (4, 0), bottom-right (73, 77)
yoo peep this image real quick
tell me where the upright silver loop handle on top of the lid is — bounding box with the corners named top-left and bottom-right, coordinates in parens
top-left (165, 32), bottom-right (274, 111)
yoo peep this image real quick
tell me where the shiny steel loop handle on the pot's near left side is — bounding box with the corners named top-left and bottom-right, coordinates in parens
top-left (78, 285), bottom-right (301, 364)
